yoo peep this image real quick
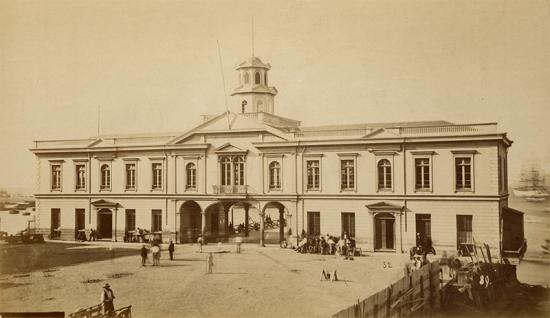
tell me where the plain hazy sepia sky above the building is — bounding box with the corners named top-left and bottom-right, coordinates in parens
top-left (0, 0), bottom-right (550, 188)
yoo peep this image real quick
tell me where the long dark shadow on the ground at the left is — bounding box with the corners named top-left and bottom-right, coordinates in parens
top-left (0, 243), bottom-right (139, 275)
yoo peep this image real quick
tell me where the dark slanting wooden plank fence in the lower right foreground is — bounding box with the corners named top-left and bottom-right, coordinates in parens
top-left (332, 261), bottom-right (441, 318)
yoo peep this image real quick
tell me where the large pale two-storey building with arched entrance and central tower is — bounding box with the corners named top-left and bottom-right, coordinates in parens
top-left (31, 56), bottom-right (523, 255)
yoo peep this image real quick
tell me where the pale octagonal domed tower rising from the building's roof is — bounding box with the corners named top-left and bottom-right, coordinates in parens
top-left (231, 56), bottom-right (277, 114)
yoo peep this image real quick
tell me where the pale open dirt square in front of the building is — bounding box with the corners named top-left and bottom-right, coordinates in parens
top-left (0, 243), bottom-right (408, 317)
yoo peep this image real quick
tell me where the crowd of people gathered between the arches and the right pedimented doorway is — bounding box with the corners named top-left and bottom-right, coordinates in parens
top-left (296, 233), bottom-right (355, 257)
